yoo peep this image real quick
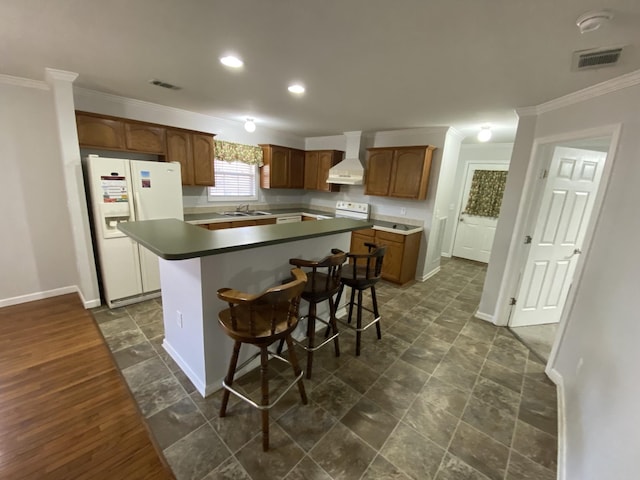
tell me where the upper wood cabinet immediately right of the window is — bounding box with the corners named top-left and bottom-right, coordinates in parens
top-left (260, 145), bottom-right (304, 188)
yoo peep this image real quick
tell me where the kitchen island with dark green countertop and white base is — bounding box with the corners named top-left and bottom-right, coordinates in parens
top-left (118, 218), bottom-right (372, 396)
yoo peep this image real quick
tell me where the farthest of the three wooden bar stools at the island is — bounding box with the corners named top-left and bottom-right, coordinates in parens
top-left (332, 242), bottom-right (387, 355)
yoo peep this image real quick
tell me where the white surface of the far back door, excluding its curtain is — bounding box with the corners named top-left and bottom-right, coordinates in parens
top-left (453, 163), bottom-right (509, 263)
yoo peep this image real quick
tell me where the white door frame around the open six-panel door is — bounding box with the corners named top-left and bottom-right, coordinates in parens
top-left (494, 124), bottom-right (622, 350)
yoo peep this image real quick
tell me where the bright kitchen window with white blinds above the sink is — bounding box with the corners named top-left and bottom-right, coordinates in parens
top-left (208, 158), bottom-right (258, 202)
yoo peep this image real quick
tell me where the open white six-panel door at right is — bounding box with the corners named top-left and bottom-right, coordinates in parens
top-left (509, 147), bottom-right (606, 327)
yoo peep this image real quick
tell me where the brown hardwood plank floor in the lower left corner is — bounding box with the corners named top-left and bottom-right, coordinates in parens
top-left (0, 294), bottom-right (175, 480)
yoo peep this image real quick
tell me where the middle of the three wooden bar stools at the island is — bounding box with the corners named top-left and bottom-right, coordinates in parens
top-left (288, 252), bottom-right (347, 378)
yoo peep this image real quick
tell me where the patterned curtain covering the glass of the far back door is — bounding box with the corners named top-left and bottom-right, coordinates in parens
top-left (463, 170), bottom-right (507, 217)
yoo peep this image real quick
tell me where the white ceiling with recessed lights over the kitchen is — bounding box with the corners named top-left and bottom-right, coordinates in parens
top-left (0, 0), bottom-right (640, 141)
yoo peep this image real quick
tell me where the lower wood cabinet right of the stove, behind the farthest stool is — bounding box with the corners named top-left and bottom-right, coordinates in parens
top-left (350, 228), bottom-right (422, 285)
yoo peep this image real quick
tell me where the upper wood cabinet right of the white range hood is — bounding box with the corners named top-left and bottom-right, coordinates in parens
top-left (364, 145), bottom-right (435, 200)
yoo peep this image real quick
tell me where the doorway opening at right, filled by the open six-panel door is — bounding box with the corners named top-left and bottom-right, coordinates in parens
top-left (509, 136), bottom-right (611, 340)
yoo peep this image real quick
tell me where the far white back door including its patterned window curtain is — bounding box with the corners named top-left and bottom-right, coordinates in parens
top-left (452, 162), bottom-right (509, 263)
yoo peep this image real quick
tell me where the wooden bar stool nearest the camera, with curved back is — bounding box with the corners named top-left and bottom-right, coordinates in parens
top-left (218, 268), bottom-right (307, 452)
